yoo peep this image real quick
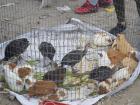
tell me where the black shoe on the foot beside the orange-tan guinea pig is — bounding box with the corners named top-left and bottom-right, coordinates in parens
top-left (109, 22), bottom-right (126, 36)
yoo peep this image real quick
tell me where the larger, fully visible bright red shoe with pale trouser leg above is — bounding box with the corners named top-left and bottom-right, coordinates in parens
top-left (74, 0), bottom-right (99, 14)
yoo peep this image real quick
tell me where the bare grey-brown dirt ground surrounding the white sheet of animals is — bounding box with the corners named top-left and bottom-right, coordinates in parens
top-left (0, 0), bottom-right (140, 105)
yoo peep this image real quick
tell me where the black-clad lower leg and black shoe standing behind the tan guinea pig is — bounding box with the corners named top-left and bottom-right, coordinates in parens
top-left (110, 0), bottom-right (126, 35)
